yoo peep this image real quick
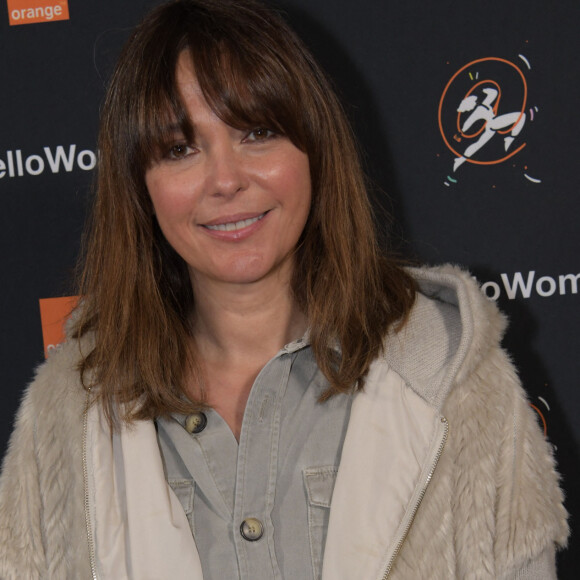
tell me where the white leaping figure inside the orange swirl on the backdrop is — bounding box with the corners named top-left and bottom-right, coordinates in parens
top-left (453, 87), bottom-right (526, 171)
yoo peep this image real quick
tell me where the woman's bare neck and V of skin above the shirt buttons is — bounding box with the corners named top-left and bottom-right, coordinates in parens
top-left (191, 272), bottom-right (307, 440)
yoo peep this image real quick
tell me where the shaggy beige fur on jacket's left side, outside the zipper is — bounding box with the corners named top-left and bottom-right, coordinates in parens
top-left (0, 341), bottom-right (88, 578)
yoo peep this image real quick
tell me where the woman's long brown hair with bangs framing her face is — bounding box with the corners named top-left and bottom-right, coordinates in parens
top-left (74, 0), bottom-right (415, 422)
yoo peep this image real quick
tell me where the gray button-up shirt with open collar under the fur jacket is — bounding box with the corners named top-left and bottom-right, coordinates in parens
top-left (157, 339), bottom-right (352, 580)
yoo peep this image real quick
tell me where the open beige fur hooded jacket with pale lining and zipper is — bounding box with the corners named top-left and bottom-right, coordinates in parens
top-left (0, 266), bottom-right (568, 580)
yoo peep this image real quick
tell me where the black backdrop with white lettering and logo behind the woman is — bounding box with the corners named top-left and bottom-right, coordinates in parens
top-left (0, 0), bottom-right (580, 578)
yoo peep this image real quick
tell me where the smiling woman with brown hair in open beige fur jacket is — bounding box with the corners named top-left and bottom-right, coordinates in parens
top-left (0, 0), bottom-right (568, 580)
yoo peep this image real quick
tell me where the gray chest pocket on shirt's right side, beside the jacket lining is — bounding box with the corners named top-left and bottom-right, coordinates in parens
top-left (302, 466), bottom-right (338, 579)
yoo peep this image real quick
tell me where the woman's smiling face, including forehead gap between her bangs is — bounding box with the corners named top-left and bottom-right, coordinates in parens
top-left (145, 55), bottom-right (311, 289)
